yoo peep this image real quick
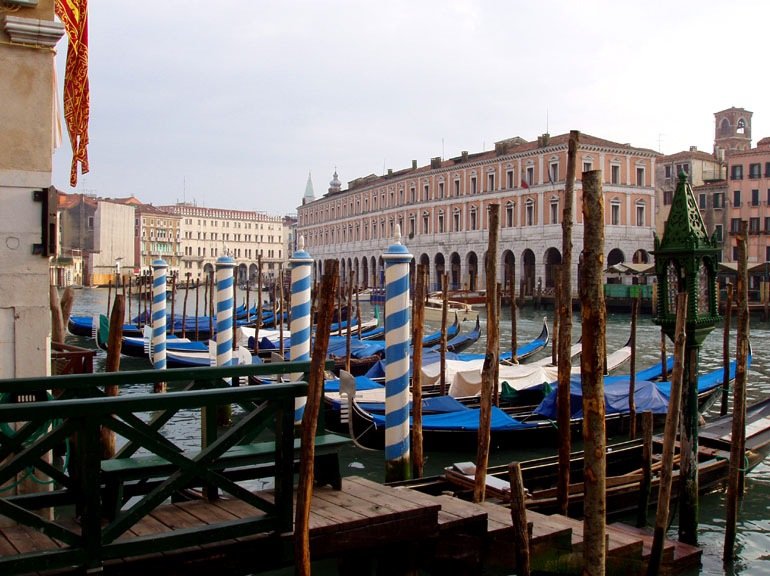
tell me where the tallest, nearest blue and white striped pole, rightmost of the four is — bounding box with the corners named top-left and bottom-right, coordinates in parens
top-left (382, 225), bottom-right (418, 482)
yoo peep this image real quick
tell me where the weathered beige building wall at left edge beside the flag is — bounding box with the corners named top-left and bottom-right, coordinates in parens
top-left (0, 2), bottom-right (64, 378)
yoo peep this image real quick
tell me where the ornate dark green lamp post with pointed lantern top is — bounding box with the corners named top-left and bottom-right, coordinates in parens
top-left (653, 173), bottom-right (720, 545)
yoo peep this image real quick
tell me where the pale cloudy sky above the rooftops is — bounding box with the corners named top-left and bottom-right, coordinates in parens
top-left (53, 0), bottom-right (770, 216)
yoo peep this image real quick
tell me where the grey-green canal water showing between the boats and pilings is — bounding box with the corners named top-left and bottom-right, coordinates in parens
top-left (68, 288), bottom-right (770, 575)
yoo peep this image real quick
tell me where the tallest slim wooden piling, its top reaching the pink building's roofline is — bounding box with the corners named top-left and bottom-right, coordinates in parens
top-left (556, 130), bottom-right (580, 515)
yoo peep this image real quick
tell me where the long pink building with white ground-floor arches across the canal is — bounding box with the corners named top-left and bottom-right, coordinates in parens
top-left (297, 134), bottom-right (660, 295)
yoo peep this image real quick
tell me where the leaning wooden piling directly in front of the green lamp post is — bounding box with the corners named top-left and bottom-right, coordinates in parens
top-left (647, 292), bottom-right (687, 576)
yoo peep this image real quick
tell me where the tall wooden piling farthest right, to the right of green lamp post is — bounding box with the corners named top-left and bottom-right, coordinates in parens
top-left (722, 226), bottom-right (749, 564)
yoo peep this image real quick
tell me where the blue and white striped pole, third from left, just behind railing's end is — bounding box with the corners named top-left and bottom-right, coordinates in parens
top-left (289, 236), bottom-right (313, 422)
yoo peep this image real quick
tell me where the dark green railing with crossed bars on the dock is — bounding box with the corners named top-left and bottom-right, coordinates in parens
top-left (0, 362), bottom-right (320, 574)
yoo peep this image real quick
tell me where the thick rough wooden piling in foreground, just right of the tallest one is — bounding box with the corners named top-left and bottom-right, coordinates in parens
top-left (580, 170), bottom-right (607, 576)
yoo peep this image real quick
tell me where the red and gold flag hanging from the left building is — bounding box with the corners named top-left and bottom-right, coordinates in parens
top-left (55, 0), bottom-right (90, 188)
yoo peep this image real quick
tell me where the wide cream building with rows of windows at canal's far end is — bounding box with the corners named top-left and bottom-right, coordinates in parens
top-left (158, 202), bottom-right (289, 284)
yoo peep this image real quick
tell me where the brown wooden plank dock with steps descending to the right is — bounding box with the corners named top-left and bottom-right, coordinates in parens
top-left (0, 476), bottom-right (701, 576)
